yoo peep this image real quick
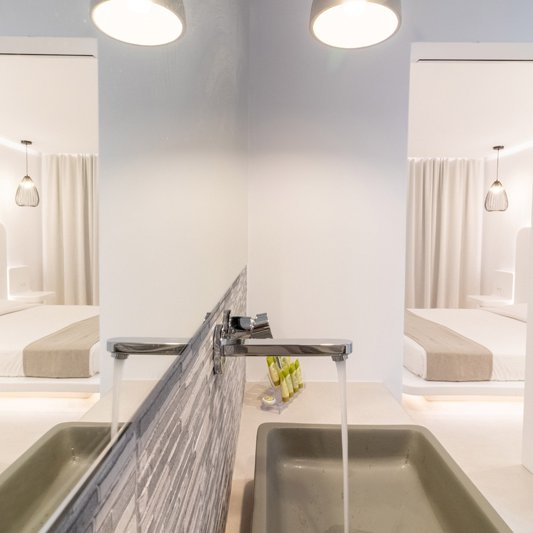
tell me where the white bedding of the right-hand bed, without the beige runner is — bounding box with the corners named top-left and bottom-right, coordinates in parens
top-left (404, 309), bottom-right (527, 381)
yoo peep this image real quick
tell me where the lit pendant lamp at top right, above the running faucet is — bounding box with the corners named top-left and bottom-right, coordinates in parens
top-left (310, 0), bottom-right (401, 48)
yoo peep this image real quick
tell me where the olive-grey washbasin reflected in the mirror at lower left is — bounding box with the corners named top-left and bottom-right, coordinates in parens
top-left (0, 422), bottom-right (110, 533)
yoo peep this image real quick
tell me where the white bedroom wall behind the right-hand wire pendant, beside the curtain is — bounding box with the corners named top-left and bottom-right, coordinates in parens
top-left (481, 149), bottom-right (533, 294)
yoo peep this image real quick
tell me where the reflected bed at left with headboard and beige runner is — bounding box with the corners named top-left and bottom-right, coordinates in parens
top-left (0, 224), bottom-right (100, 393)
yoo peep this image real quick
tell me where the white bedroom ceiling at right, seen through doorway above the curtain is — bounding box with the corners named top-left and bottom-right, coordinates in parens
top-left (408, 61), bottom-right (533, 157)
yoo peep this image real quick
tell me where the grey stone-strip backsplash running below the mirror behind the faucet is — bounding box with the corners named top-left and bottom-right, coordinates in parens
top-left (53, 270), bottom-right (246, 533)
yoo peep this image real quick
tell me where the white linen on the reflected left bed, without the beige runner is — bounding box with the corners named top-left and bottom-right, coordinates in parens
top-left (0, 304), bottom-right (100, 377)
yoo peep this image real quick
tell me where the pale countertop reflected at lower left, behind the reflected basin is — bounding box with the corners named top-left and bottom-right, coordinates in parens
top-left (0, 394), bottom-right (99, 472)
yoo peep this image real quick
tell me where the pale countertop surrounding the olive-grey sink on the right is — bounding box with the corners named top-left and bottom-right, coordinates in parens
top-left (226, 383), bottom-right (533, 533)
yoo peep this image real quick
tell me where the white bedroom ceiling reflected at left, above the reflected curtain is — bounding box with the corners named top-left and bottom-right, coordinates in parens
top-left (0, 55), bottom-right (98, 153)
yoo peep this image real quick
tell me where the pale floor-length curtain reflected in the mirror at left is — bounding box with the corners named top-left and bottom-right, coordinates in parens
top-left (42, 154), bottom-right (98, 305)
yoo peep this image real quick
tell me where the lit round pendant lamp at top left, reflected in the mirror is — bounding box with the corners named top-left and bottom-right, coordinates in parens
top-left (91, 0), bottom-right (185, 46)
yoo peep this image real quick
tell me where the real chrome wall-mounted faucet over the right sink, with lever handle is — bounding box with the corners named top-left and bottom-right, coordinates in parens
top-left (213, 311), bottom-right (352, 374)
